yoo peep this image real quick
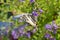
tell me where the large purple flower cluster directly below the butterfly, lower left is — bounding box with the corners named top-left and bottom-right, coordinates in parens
top-left (11, 24), bottom-right (36, 39)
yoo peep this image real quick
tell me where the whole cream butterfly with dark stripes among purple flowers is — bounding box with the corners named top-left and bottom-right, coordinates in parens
top-left (13, 13), bottom-right (37, 26)
